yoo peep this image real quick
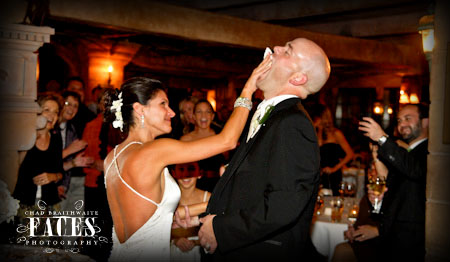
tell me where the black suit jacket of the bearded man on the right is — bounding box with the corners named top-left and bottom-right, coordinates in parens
top-left (378, 139), bottom-right (428, 261)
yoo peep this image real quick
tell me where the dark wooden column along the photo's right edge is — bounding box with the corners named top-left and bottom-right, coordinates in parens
top-left (426, 0), bottom-right (450, 261)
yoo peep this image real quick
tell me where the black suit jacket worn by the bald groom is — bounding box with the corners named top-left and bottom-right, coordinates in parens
top-left (207, 98), bottom-right (320, 261)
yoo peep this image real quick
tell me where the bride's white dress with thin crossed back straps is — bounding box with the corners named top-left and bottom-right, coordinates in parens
top-left (105, 142), bottom-right (181, 261)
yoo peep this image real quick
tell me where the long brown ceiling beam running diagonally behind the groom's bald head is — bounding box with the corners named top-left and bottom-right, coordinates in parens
top-left (50, 0), bottom-right (423, 73)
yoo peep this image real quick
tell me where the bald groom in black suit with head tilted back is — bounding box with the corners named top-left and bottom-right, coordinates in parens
top-left (199, 38), bottom-right (330, 261)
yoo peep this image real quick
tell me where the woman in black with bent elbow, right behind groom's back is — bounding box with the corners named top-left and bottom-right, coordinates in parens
top-left (311, 104), bottom-right (354, 196)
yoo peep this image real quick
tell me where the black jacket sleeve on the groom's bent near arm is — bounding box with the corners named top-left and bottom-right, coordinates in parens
top-left (212, 113), bottom-right (320, 252)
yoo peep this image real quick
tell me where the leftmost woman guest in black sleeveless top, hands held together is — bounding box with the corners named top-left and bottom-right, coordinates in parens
top-left (13, 93), bottom-right (63, 221)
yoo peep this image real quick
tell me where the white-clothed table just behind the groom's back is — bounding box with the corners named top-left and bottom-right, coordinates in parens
top-left (311, 197), bottom-right (357, 261)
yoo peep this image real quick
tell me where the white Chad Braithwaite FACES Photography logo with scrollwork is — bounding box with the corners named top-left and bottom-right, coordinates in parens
top-left (16, 200), bottom-right (108, 253)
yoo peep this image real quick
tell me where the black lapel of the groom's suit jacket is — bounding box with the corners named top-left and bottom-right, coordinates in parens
top-left (208, 98), bottom-right (301, 207)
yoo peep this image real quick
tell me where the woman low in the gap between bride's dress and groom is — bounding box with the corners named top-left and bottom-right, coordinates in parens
top-left (170, 162), bottom-right (211, 261)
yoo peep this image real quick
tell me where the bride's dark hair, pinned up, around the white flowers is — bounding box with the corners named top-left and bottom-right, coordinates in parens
top-left (103, 77), bottom-right (164, 133)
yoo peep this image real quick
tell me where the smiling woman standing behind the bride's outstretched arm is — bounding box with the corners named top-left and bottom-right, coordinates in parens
top-left (180, 99), bottom-right (225, 192)
